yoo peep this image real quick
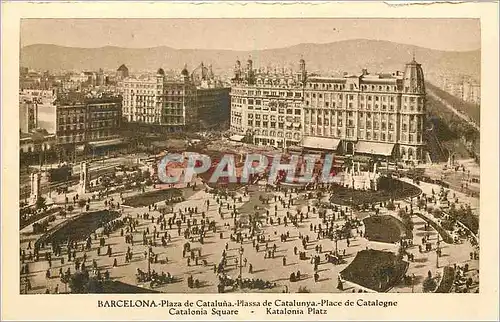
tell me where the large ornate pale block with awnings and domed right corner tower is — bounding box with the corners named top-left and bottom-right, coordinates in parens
top-left (231, 59), bottom-right (426, 161)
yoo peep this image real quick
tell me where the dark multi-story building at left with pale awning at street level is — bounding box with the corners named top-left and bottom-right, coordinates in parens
top-left (56, 95), bottom-right (123, 156)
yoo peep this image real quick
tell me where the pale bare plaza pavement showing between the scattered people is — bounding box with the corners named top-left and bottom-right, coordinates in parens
top-left (21, 167), bottom-right (478, 293)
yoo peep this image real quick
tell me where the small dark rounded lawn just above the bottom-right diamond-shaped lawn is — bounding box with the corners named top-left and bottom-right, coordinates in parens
top-left (363, 215), bottom-right (411, 244)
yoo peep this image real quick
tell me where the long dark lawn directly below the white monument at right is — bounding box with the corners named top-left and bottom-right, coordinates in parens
top-left (330, 177), bottom-right (421, 206)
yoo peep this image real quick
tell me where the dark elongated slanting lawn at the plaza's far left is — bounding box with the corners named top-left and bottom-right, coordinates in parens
top-left (37, 210), bottom-right (120, 243)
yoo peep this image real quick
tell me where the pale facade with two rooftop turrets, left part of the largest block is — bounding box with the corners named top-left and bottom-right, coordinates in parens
top-left (231, 60), bottom-right (307, 148)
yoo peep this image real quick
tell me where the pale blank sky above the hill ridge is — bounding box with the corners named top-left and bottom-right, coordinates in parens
top-left (21, 18), bottom-right (481, 51)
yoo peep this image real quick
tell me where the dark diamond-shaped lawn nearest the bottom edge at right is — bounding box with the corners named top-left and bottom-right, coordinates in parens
top-left (340, 249), bottom-right (408, 292)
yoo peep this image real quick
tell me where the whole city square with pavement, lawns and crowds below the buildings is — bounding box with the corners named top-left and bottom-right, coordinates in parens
top-left (21, 141), bottom-right (479, 293)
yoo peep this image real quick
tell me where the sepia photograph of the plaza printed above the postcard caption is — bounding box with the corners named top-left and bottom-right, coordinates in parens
top-left (16, 18), bottom-right (483, 296)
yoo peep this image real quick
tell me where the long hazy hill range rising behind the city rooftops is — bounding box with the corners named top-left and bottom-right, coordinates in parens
top-left (20, 39), bottom-right (481, 78)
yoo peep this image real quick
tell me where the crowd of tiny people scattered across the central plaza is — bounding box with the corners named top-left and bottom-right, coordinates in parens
top-left (21, 156), bottom-right (480, 292)
